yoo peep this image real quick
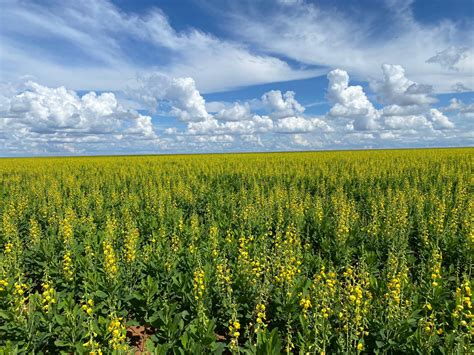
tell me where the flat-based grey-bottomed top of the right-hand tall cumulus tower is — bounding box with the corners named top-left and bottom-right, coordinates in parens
top-left (370, 64), bottom-right (436, 106)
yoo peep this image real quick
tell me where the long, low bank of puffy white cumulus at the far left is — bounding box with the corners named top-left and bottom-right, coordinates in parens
top-left (1, 81), bottom-right (154, 136)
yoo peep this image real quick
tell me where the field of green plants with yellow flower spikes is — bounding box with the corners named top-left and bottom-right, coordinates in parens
top-left (0, 149), bottom-right (474, 354)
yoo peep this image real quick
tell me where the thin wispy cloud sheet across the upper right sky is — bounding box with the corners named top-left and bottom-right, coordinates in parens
top-left (228, 1), bottom-right (474, 93)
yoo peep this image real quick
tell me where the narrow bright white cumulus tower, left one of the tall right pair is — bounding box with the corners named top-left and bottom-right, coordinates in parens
top-left (327, 69), bottom-right (379, 130)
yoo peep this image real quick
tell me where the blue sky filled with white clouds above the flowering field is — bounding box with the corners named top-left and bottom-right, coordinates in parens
top-left (0, 0), bottom-right (474, 157)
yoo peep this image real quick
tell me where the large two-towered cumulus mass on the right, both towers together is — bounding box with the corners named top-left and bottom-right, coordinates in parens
top-left (327, 64), bottom-right (454, 134)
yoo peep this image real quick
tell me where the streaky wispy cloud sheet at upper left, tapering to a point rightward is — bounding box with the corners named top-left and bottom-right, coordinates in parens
top-left (0, 0), bottom-right (321, 92)
